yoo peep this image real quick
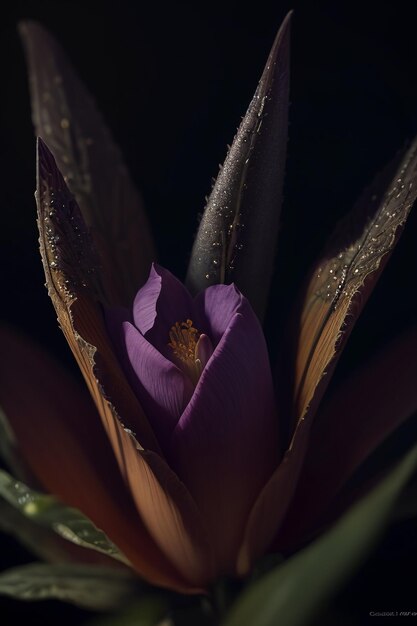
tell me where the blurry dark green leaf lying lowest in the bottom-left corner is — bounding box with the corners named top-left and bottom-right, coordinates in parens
top-left (0, 563), bottom-right (139, 611)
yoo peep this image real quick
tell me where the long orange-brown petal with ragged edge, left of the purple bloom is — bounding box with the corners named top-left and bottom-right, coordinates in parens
top-left (37, 140), bottom-right (213, 586)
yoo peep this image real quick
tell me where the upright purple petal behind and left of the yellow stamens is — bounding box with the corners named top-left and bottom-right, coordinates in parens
top-left (133, 263), bottom-right (194, 356)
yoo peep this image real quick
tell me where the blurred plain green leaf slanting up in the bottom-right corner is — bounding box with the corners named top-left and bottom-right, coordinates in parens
top-left (223, 438), bottom-right (417, 626)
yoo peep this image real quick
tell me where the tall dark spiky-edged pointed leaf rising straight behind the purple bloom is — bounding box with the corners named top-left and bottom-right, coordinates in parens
top-left (187, 13), bottom-right (291, 317)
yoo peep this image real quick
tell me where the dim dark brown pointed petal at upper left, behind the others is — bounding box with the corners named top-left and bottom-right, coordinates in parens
top-left (19, 21), bottom-right (155, 306)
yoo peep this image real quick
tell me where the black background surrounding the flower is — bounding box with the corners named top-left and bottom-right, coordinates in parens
top-left (0, 0), bottom-right (417, 626)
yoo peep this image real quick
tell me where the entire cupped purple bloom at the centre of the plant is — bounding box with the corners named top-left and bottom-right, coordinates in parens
top-left (107, 265), bottom-right (279, 572)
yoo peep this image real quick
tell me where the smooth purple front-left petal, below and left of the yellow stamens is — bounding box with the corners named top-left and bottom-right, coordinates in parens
top-left (123, 322), bottom-right (193, 447)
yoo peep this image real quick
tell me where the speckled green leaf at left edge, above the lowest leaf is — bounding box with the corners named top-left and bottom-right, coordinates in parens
top-left (0, 470), bottom-right (129, 565)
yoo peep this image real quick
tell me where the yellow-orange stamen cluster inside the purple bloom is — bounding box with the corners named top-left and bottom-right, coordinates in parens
top-left (168, 320), bottom-right (213, 386)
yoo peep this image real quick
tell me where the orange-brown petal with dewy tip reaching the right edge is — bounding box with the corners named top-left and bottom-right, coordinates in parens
top-left (239, 140), bottom-right (417, 572)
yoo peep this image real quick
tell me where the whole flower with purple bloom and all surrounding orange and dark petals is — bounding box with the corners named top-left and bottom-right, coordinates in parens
top-left (1, 13), bottom-right (417, 593)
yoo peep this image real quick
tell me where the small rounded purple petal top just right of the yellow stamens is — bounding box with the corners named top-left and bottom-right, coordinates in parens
top-left (195, 285), bottom-right (244, 345)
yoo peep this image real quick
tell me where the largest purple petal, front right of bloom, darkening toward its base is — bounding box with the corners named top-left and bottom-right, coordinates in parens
top-left (171, 302), bottom-right (279, 571)
